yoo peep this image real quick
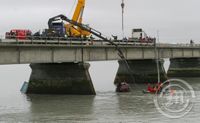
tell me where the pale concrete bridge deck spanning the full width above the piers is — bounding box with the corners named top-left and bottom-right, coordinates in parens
top-left (0, 40), bottom-right (200, 64)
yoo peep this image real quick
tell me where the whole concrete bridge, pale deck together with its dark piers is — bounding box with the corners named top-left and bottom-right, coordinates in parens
top-left (0, 40), bottom-right (200, 94)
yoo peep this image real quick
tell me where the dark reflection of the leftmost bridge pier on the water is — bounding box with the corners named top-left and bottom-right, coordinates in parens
top-left (28, 95), bottom-right (94, 121)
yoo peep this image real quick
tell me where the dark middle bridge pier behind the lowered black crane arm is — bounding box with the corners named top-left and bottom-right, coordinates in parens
top-left (115, 59), bottom-right (167, 84)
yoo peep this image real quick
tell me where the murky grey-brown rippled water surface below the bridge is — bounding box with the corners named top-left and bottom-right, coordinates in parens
top-left (0, 78), bottom-right (200, 123)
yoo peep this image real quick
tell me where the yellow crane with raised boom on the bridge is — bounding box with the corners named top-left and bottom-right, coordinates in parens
top-left (65, 0), bottom-right (91, 37)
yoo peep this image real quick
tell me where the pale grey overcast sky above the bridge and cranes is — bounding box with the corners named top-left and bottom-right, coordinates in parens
top-left (0, 0), bottom-right (200, 43)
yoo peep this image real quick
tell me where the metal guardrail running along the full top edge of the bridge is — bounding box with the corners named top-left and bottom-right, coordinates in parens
top-left (0, 36), bottom-right (200, 48)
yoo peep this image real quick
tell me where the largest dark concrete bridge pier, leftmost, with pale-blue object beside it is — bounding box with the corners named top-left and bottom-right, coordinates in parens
top-left (21, 63), bottom-right (95, 95)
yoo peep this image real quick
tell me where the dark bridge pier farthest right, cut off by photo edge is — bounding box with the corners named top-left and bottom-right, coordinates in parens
top-left (167, 58), bottom-right (200, 77)
